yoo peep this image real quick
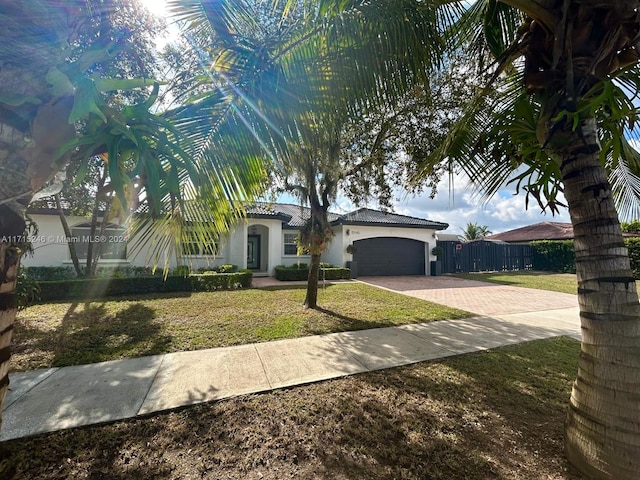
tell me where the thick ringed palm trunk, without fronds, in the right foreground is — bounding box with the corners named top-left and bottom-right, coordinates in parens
top-left (561, 120), bottom-right (640, 480)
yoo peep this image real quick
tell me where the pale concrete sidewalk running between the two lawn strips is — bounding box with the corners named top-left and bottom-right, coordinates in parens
top-left (0, 277), bottom-right (580, 441)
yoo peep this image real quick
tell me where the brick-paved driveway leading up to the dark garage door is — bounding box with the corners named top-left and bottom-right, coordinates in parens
top-left (358, 276), bottom-right (578, 316)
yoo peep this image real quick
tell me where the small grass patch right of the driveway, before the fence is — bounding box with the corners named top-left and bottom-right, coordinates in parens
top-left (455, 271), bottom-right (578, 294)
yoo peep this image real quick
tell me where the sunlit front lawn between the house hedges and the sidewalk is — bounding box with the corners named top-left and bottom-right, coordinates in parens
top-left (12, 283), bottom-right (472, 371)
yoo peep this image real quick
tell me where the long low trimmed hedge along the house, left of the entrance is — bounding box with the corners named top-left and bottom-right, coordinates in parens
top-left (33, 270), bottom-right (252, 302)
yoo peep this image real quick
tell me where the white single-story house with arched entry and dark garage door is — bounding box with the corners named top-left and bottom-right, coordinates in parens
top-left (23, 204), bottom-right (448, 276)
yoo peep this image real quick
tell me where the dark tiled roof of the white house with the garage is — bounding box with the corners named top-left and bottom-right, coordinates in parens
top-left (247, 203), bottom-right (449, 230)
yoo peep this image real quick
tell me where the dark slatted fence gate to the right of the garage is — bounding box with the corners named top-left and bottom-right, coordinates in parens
top-left (436, 240), bottom-right (533, 273)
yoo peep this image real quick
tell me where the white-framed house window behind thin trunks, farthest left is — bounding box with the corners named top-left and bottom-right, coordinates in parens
top-left (69, 224), bottom-right (128, 260)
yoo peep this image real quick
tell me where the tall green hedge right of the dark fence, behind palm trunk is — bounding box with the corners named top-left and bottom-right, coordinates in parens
top-left (531, 237), bottom-right (640, 279)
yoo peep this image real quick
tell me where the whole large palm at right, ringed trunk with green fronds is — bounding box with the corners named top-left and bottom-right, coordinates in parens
top-left (410, 0), bottom-right (640, 479)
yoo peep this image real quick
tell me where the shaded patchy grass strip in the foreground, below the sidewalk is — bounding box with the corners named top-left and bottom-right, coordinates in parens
top-left (0, 338), bottom-right (581, 480)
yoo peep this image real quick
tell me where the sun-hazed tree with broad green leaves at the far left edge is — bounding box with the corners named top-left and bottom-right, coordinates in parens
top-left (0, 0), bottom-right (263, 432)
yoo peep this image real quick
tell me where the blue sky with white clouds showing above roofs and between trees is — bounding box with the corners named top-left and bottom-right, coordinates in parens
top-left (139, 0), bottom-right (570, 238)
